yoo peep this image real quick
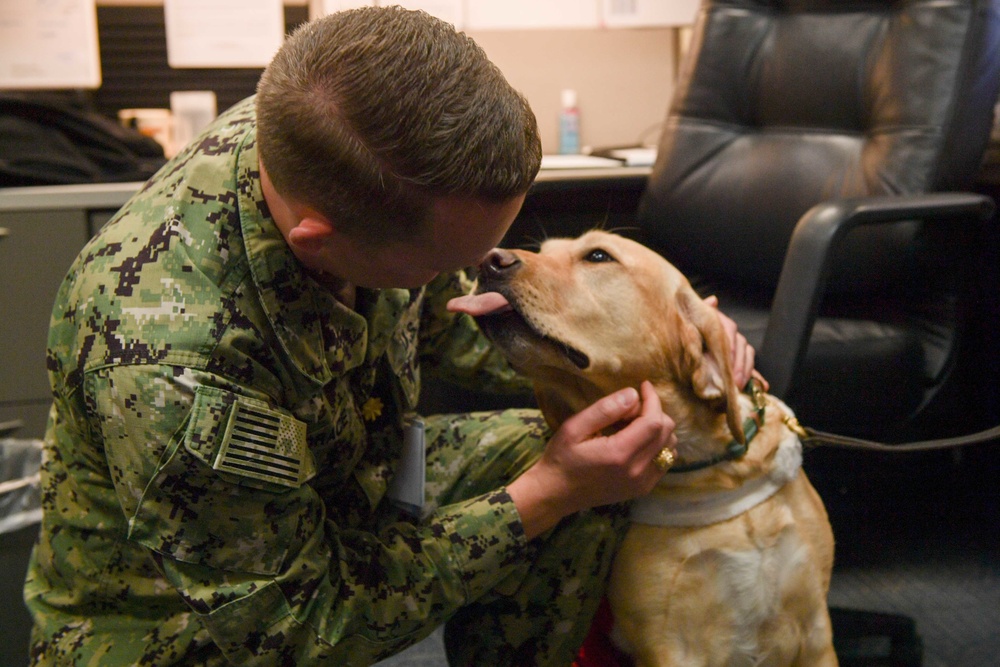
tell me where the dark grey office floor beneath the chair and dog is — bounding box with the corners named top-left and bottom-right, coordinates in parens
top-left (380, 443), bottom-right (1000, 667)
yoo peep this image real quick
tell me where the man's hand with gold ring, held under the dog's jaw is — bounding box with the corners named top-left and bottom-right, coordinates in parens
top-left (507, 382), bottom-right (677, 539)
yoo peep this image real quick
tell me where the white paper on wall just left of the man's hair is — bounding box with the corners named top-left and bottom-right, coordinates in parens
top-left (163, 0), bottom-right (285, 68)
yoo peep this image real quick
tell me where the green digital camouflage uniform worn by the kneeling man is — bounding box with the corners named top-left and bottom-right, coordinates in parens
top-left (25, 100), bottom-right (624, 667)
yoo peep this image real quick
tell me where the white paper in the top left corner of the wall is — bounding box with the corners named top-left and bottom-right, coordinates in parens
top-left (0, 0), bottom-right (101, 90)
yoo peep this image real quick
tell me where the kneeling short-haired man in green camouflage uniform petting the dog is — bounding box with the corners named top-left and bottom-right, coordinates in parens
top-left (25, 8), bottom-right (736, 667)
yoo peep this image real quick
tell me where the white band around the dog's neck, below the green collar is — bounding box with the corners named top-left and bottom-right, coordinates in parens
top-left (630, 432), bottom-right (802, 527)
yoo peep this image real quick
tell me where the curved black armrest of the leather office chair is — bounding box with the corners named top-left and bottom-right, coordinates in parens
top-left (757, 192), bottom-right (994, 397)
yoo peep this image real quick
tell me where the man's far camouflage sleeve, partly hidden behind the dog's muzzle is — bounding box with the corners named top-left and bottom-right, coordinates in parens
top-left (420, 271), bottom-right (531, 393)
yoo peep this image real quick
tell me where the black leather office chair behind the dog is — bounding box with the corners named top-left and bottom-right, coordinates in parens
top-left (638, 0), bottom-right (1000, 440)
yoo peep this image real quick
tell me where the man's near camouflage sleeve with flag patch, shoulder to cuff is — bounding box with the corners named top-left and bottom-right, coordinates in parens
top-left (94, 366), bottom-right (526, 665)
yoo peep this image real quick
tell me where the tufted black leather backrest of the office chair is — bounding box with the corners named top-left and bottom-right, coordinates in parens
top-left (638, 0), bottom-right (1000, 290)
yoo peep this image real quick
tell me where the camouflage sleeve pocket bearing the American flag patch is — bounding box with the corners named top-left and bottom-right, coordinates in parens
top-left (129, 387), bottom-right (320, 575)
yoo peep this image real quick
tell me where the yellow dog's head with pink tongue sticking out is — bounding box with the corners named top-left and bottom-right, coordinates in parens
top-left (452, 231), bottom-right (743, 442)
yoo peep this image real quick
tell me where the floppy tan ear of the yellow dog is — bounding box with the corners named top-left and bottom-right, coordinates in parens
top-left (677, 288), bottom-right (746, 444)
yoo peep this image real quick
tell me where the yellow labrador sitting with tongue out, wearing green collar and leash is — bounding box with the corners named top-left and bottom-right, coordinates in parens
top-left (452, 231), bottom-right (837, 667)
